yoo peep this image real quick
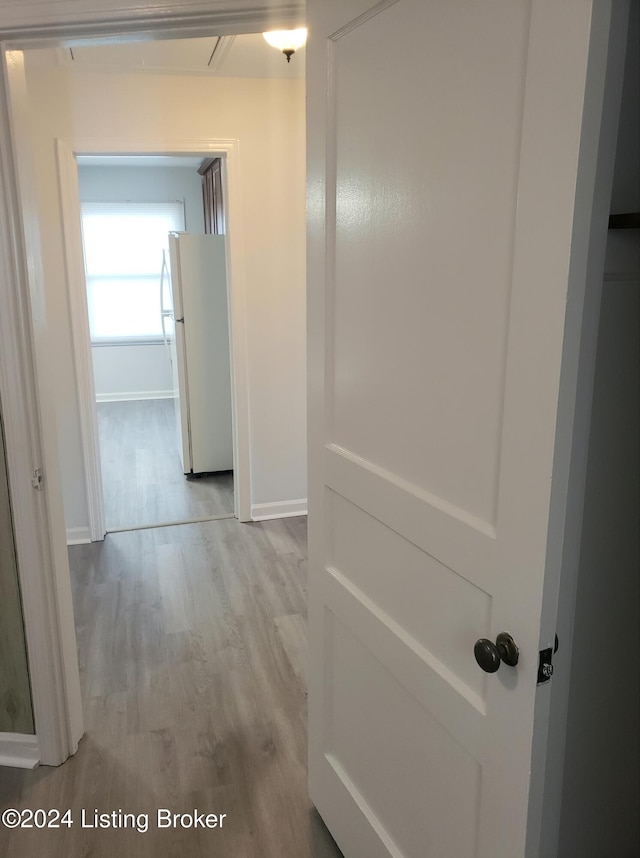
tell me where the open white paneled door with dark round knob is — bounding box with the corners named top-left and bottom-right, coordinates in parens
top-left (307, 0), bottom-right (624, 858)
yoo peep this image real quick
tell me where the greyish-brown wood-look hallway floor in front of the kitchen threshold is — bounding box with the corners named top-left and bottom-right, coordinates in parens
top-left (0, 518), bottom-right (340, 858)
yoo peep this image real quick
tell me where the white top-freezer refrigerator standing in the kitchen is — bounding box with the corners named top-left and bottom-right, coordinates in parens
top-left (160, 233), bottom-right (233, 476)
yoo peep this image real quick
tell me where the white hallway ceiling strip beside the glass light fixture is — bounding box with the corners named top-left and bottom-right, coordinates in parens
top-left (30, 33), bottom-right (305, 78)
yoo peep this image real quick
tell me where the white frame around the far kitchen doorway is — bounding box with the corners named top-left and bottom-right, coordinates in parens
top-left (55, 137), bottom-right (251, 542)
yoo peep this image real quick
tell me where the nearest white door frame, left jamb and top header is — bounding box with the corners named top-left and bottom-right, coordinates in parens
top-left (0, 0), bottom-right (305, 765)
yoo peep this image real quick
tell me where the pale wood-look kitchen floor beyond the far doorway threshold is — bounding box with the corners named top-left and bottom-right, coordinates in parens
top-left (97, 399), bottom-right (233, 530)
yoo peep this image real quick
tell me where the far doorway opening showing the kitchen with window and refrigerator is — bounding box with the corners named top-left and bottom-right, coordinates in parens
top-left (75, 150), bottom-right (234, 532)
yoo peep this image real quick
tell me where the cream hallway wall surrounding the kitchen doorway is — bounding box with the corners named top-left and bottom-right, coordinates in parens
top-left (26, 55), bottom-right (306, 528)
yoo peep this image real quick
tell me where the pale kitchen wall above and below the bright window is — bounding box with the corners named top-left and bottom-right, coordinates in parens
top-left (78, 164), bottom-right (204, 402)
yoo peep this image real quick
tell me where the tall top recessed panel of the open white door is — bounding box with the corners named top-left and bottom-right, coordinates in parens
top-left (328, 0), bottom-right (529, 526)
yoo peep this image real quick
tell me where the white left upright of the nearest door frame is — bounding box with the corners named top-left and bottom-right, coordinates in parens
top-left (0, 51), bottom-right (83, 765)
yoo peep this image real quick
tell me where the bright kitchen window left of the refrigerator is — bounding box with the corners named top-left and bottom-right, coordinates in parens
top-left (81, 201), bottom-right (184, 343)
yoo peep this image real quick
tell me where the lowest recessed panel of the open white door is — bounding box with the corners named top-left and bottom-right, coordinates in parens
top-left (326, 614), bottom-right (481, 858)
